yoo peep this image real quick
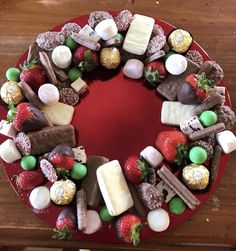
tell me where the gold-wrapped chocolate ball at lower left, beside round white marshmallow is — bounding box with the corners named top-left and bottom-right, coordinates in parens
top-left (50, 179), bottom-right (76, 205)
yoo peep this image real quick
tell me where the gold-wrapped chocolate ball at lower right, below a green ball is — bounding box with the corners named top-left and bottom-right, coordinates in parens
top-left (182, 164), bottom-right (210, 190)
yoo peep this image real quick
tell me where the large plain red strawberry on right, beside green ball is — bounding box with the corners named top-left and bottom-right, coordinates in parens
top-left (155, 131), bottom-right (188, 165)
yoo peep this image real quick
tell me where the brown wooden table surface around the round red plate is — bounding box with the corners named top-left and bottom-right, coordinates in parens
top-left (0, 0), bottom-right (236, 250)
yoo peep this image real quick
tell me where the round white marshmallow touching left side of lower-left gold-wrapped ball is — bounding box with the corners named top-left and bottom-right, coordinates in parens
top-left (29, 186), bottom-right (51, 210)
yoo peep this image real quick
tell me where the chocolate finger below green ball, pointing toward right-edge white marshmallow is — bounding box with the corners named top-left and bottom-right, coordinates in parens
top-left (188, 123), bottom-right (225, 141)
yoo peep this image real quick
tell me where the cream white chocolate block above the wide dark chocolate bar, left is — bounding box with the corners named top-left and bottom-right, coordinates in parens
top-left (41, 102), bottom-right (74, 125)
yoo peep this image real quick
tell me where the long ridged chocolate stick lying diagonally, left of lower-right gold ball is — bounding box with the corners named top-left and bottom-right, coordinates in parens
top-left (157, 166), bottom-right (200, 210)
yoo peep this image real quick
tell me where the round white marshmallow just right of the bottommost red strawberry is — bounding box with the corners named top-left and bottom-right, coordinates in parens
top-left (147, 208), bottom-right (170, 232)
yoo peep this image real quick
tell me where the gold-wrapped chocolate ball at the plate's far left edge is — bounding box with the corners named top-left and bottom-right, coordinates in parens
top-left (1, 81), bottom-right (25, 105)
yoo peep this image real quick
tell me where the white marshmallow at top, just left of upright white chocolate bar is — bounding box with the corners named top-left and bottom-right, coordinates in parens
top-left (95, 19), bottom-right (118, 41)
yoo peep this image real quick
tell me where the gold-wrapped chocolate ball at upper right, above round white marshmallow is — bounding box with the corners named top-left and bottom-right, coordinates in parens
top-left (168, 29), bottom-right (193, 53)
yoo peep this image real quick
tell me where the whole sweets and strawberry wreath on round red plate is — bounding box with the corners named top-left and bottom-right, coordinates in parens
top-left (0, 10), bottom-right (236, 245)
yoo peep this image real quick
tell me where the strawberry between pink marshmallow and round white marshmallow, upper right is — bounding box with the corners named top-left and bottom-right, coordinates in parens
top-left (144, 61), bottom-right (167, 87)
